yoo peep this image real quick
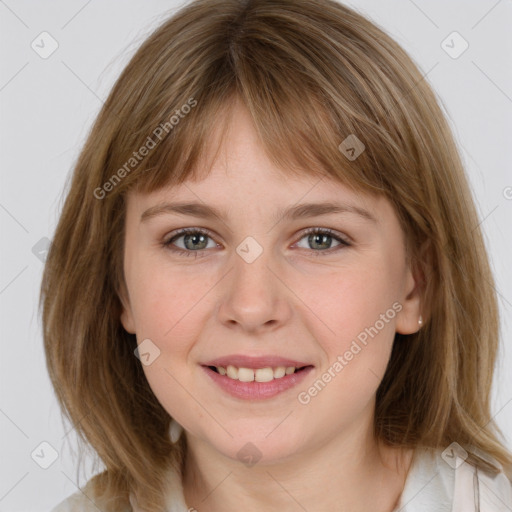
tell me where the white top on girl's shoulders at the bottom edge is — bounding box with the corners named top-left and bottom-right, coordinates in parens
top-left (51, 448), bottom-right (512, 512)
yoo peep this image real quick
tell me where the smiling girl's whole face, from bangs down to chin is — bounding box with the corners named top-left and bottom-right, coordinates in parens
top-left (121, 102), bottom-right (420, 462)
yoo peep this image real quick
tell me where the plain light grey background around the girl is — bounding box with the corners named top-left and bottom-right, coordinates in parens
top-left (0, 0), bottom-right (512, 512)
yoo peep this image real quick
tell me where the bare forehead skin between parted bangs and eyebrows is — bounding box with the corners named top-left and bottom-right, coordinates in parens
top-left (128, 101), bottom-right (373, 208)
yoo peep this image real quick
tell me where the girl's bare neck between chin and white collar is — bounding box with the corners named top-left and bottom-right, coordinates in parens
top-left (183, 418), bottom-right (412, 512)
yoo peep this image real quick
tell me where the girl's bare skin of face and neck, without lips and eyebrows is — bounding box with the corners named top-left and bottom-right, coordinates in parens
top-left (121, 98), bottom-right (421, 512)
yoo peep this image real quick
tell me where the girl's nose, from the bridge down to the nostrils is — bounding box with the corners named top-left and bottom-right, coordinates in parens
top-left (217, 241), bottom-right (292, 334)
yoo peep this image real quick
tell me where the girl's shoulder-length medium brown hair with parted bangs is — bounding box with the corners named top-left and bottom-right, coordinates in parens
top-left (41, 0), bottom-right (512, 512)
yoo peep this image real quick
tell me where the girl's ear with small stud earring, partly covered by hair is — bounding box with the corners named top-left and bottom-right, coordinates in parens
top-left (396, 246), bottom-right (428, 334)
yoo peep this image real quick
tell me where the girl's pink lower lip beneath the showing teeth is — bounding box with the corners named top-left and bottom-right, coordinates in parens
top-left (202, 366), bottom-right (313, 400)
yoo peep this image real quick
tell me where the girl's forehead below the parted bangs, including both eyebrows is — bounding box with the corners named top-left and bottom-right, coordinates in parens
top-left (124, 101), bottom-right (400, 230)
